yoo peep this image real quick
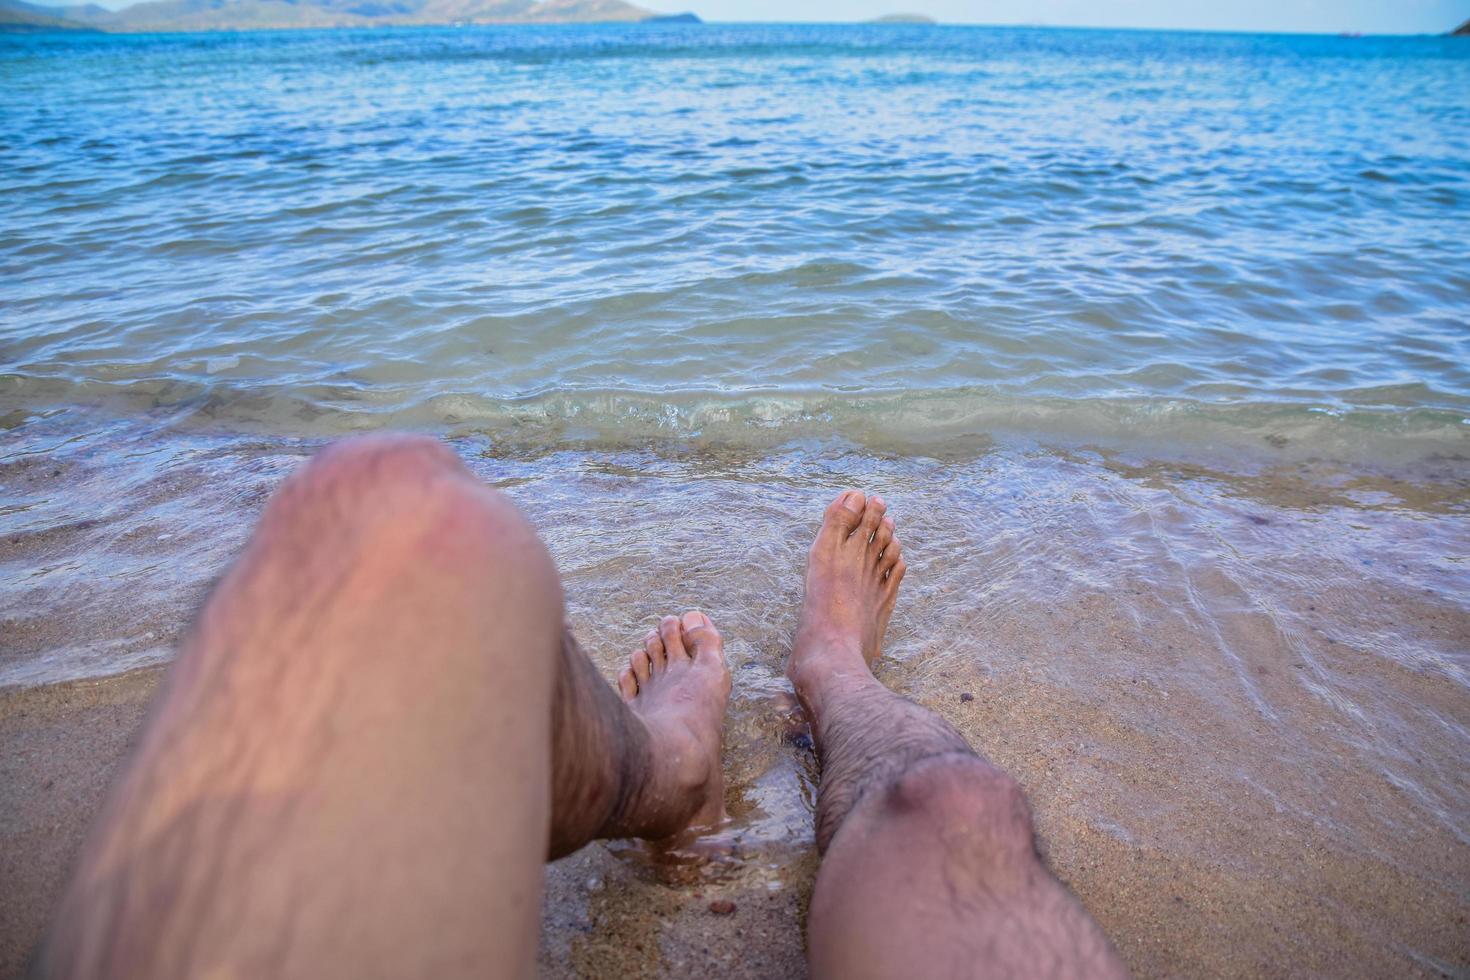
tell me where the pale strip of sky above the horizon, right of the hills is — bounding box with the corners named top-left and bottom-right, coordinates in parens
top-left (687, 0), bottom-right (1470, 34)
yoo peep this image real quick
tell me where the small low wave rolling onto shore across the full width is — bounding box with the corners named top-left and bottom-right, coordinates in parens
top-left (0, 376), bottom-right (1470, 464)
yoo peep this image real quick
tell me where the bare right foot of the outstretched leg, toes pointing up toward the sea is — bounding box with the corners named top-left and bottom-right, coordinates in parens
top-left (786, 491), bottom-right (906, 708)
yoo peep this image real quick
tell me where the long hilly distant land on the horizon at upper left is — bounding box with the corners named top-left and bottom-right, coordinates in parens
top-left (0, 0), bottom-right (701, 34)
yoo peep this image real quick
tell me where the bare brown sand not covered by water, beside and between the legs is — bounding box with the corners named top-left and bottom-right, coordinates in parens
top-left (0, 631), bottom-right (1470, 977)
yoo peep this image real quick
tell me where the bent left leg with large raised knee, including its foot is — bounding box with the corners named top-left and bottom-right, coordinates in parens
top-left (38, 438), bottom-right (729, 977)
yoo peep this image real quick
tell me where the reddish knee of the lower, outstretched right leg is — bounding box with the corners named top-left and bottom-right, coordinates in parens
top-left (883, 755), bottom-right (1036, 861)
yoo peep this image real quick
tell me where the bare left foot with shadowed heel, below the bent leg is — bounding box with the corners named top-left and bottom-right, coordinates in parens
top-left (617, 611), bottom-right (731, 839)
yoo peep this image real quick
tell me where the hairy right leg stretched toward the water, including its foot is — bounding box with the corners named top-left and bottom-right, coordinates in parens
top-left (786, 491), bottom-right (1125, 977)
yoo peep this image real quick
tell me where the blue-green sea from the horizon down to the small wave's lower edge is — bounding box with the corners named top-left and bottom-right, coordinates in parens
top-left (0, 26), bottom-right (1470, 458)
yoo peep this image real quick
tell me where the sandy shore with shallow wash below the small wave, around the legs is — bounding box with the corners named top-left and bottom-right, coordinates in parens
top-left (0, 417), bottom-right (1470, 977)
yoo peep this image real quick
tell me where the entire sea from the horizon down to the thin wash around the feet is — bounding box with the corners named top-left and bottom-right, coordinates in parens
top-left (0, 25), bottom-right (1470, 973)
